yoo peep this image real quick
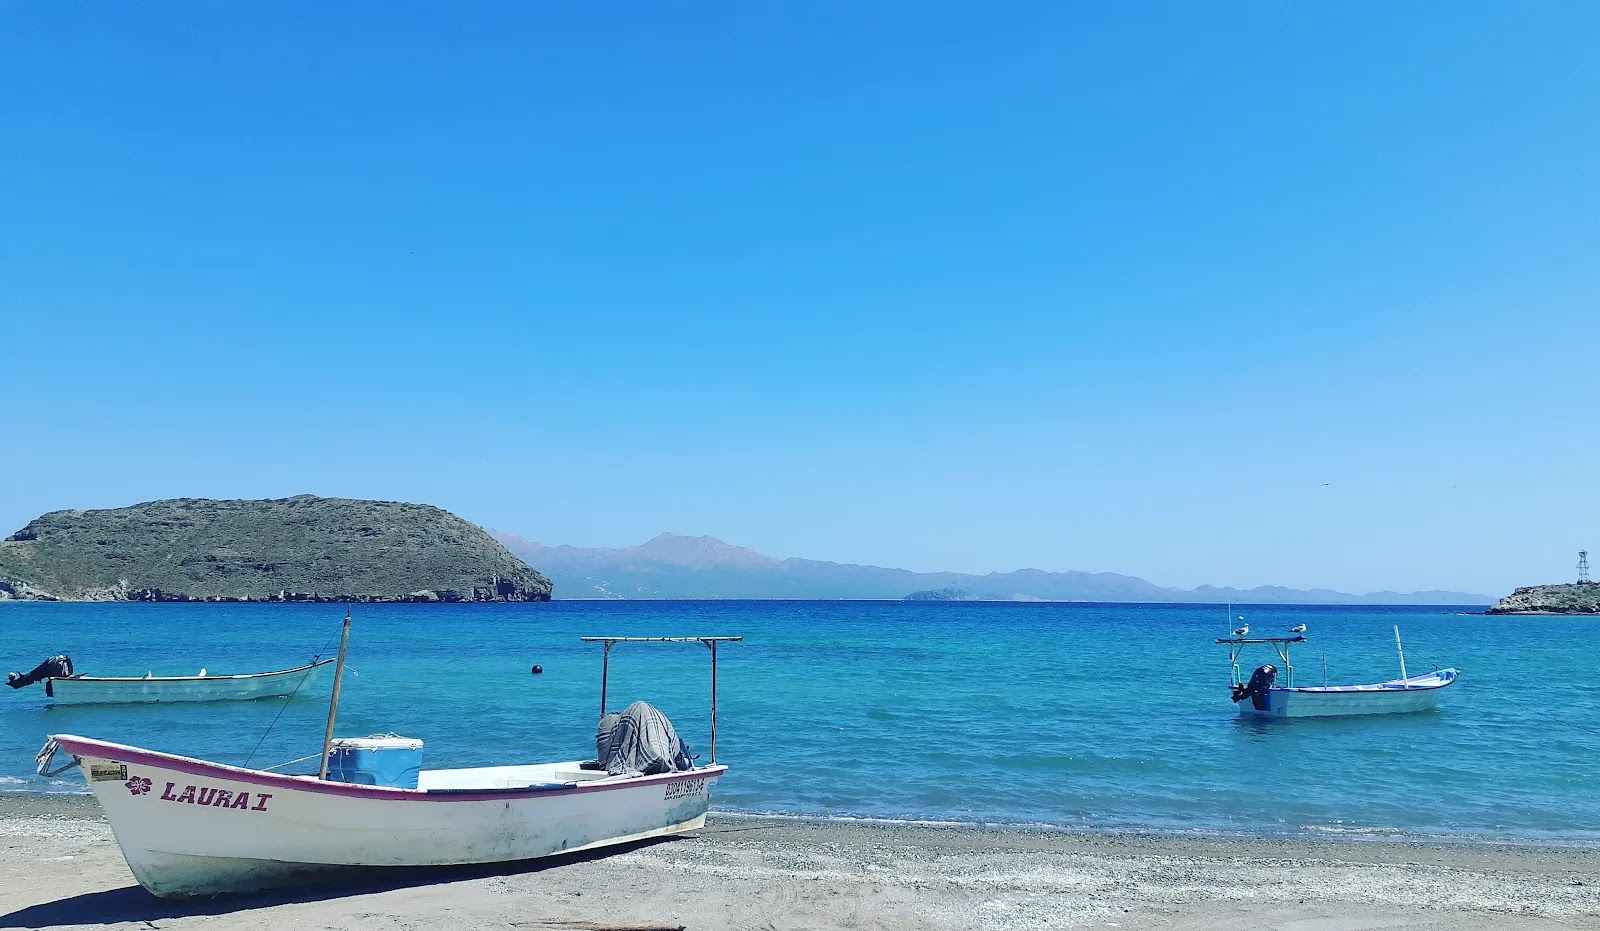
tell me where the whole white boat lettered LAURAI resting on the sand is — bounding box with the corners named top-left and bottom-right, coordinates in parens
top-left (40, 621), bottom-right (739, 896)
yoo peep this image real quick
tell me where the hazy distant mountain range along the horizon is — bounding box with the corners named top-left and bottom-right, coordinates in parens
top-left (490, 531), bottom-right (1494, 605)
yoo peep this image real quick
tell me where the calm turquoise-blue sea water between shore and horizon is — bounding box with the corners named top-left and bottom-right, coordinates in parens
top-left (0, 601), bottom-right (1600, 845)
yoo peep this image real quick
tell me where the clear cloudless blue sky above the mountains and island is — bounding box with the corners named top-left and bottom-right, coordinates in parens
top-left (0, 2), bottom-right (1600, 593)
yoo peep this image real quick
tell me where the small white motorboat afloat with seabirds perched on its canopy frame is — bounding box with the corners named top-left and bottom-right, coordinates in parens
top-left (1218, 627), bottom-right (1461, 720)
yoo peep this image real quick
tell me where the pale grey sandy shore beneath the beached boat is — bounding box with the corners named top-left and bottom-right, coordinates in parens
top-left (0, 797), bottom-right (1600, 931)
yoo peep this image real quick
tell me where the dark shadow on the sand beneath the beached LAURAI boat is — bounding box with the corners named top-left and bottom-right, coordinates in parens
top-left (0, 837), bottom-right (682, 928)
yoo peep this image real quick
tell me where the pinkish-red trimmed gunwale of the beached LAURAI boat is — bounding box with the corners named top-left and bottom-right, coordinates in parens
top-left (51, 734), bottom-right (728, 801)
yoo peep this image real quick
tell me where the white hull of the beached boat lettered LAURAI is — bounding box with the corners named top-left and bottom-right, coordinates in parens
top-left (56, 736), bottom-right (726, 897)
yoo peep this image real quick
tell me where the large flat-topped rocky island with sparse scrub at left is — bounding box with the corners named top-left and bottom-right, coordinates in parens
top-left (0, 494), bottom-right (552, 601)
